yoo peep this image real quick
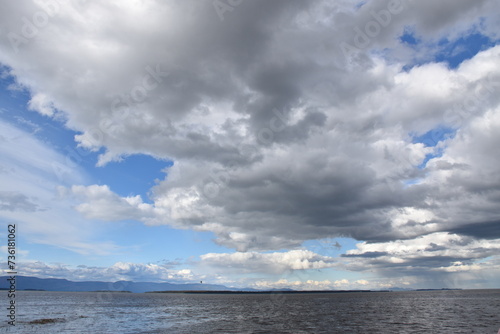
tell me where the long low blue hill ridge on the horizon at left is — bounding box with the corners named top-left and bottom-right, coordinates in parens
top-left (0, 276), bottom-right (255, 292)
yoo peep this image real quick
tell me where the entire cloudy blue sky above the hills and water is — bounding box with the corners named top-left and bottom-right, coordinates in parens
top-left (0, 0), bottom-right (500, 290)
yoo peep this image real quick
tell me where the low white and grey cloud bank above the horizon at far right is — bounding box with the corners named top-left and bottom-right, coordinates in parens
top-left (339, 232), bottom-right (500, 288)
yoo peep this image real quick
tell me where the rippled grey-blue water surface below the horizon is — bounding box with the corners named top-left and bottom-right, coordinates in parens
top-left (0, 290), bottom-right (500, 334)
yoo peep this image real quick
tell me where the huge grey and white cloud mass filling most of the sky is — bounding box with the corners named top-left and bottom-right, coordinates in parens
top-left (0, 0), bottom-right (500, 284)
